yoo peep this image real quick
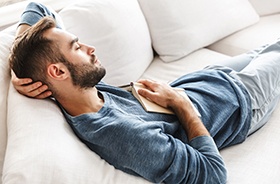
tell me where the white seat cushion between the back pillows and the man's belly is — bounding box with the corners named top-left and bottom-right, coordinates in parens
top-left (141, 49), bottom-right (230, 82)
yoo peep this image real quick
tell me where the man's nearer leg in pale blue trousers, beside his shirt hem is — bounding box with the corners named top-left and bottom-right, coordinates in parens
top-left (232, 41), bottom-right (280, 134)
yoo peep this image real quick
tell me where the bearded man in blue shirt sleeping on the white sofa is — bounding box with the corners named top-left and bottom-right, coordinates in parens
top-left (10, 1), bottom-right (280, 184)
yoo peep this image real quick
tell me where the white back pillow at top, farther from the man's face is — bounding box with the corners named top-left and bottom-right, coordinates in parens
top-left (138, 0), bottom-right (259, 62)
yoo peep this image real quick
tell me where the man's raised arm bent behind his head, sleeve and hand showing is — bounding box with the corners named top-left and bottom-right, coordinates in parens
top-left (12, 3), bottom-right (62, 99)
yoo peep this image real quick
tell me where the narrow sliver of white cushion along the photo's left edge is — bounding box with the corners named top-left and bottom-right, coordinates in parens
top-left (0, 32), bottom-right (14, 183)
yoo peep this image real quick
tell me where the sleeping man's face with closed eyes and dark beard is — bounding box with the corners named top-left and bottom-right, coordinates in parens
top-left (45, 28), bottom-right (106, 89)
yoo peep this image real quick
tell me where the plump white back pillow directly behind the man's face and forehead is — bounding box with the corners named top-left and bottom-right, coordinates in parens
top-left (59, 0), bottom-right (153, 85)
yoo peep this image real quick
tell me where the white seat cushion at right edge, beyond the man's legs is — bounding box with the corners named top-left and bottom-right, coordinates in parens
top-left (208, 14), bottom-right (280, 56)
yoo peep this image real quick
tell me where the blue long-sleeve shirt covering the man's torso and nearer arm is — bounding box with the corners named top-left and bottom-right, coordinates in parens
top-left (61, 70), bottom-right (251, 184)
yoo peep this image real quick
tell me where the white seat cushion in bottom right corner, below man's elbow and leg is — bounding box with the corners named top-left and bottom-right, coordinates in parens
top-left (221, 104), bottom-right (280, 184)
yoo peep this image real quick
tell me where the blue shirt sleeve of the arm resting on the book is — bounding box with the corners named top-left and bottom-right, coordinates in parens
top-left (77, 121), bottom-right (226, 184)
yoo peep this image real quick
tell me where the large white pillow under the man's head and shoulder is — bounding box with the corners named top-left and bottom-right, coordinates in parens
top-left (3, 85), bottom-right (151, 184)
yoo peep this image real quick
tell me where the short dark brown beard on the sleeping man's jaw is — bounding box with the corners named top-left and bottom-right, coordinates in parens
top-left (66, 58), bottom-right (106, 89)
